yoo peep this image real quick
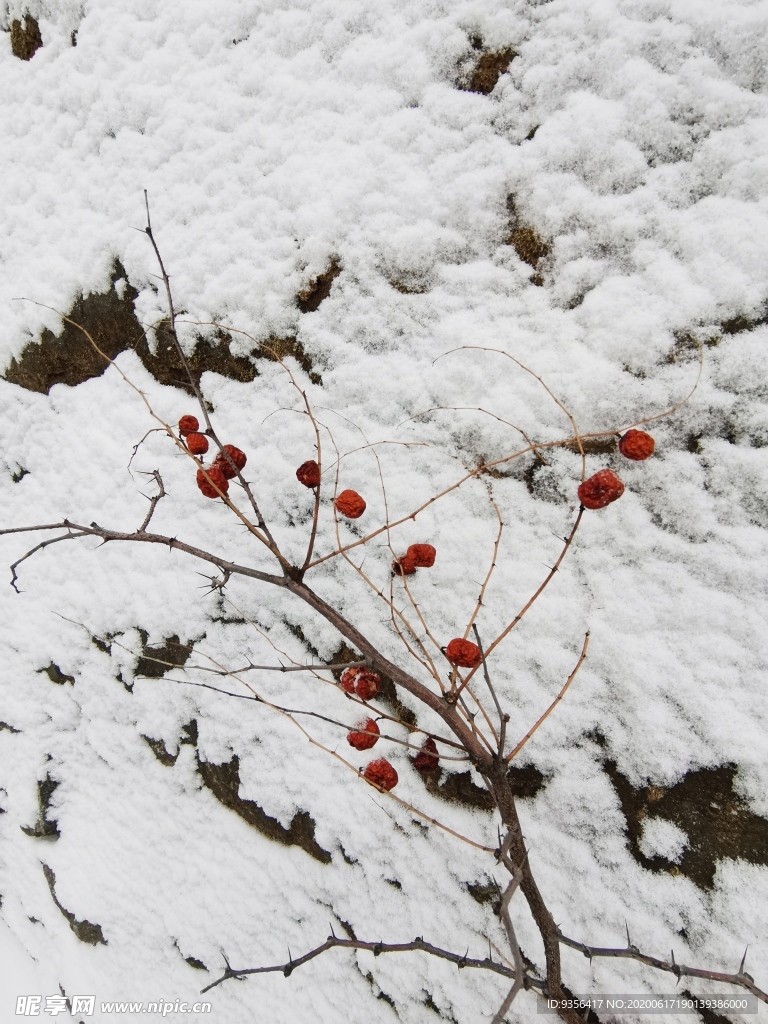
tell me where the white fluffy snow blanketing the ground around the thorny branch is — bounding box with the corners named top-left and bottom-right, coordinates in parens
top-left (0, 0), bottom-right (768, 1024)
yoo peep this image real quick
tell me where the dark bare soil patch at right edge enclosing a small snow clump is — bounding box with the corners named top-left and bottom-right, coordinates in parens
top-left (603, 761), bottom-right (768, 890)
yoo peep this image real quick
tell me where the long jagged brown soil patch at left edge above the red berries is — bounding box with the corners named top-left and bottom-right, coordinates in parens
top-left (4, 259), bottom-right (321, 394)
